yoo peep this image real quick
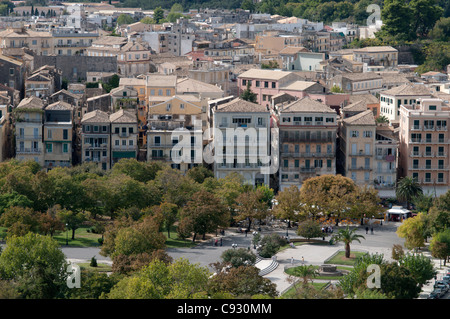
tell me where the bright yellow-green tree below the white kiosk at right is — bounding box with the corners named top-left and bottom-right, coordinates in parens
top-left (397, 213), bottom-right (425, 249)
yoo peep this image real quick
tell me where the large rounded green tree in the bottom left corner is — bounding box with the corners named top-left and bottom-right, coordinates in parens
top-left (0, 233), bottom-right (67, 299)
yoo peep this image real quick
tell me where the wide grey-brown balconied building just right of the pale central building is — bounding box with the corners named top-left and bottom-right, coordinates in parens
top-left (278, 97), bottom-right (338, 190)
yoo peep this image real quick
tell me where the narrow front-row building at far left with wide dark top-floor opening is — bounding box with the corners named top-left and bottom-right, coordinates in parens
top-left (43, 101), bottom-right (74, 169)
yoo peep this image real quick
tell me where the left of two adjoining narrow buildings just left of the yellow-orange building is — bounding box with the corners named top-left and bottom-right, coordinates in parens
top-left (81, 110), bottom-right (111, 170)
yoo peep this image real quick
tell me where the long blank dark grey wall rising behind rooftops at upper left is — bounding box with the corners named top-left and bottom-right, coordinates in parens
top-left (34, 55), bottom-right (117, 82)
